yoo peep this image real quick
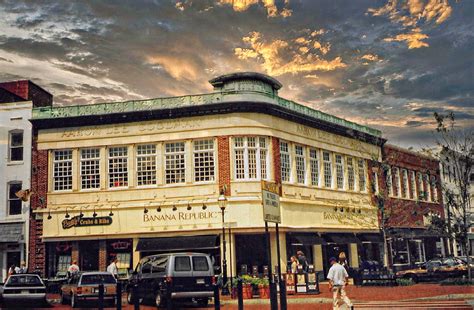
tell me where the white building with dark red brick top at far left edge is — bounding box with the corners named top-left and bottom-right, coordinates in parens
top-left (0, 81), bottom-right (52, 282)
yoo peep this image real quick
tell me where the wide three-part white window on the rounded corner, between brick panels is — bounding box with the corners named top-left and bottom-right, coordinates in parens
top-left (234, 137), bottom-right (268, 180)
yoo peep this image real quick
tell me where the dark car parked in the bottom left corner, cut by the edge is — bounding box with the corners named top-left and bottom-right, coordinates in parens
top-left (2, 273), bottom-right (47, 305)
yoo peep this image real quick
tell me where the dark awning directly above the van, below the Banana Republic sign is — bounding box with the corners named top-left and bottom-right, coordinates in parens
top-left (137, 235), bottom-right (219, 252)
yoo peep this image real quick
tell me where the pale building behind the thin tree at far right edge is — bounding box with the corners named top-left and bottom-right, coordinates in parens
top-left (436, 149), bottom-right (474, 256)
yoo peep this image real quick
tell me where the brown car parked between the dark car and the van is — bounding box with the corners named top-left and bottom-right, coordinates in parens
top-left (60, 271), bottom-right (117, 308)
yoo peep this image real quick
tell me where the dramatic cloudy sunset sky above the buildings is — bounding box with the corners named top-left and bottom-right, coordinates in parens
top-left (0, 0), bottom-right (474, 148)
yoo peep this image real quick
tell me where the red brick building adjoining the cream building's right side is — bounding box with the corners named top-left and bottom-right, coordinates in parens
top-left (372, 144), bottom-right (445, 269)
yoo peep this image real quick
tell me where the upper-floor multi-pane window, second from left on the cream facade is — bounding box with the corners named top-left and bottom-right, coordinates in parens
top-left (81, 149), bottom-right (100, 189)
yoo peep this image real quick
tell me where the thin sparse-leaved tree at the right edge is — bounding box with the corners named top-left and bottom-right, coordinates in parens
top-left (433, 112), bottom-right (474, 281)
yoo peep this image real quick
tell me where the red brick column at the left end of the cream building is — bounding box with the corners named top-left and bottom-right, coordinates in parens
top-left (28, 130), bottom-right (48, 276)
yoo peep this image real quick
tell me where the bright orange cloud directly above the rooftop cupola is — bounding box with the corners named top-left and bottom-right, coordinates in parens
top-left (234, 32), bottom-right (347, 76)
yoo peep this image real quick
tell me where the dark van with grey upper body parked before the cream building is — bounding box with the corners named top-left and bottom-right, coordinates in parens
top-left (127, 253), bottom-right (216, 307)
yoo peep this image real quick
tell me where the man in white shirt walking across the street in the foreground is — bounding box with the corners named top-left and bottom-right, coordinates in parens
top-left (327, 257), bottom-right (353, 310)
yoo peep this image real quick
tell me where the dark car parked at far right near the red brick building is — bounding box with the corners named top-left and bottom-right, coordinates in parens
top-left (396, 257), bottom-right (467, 282)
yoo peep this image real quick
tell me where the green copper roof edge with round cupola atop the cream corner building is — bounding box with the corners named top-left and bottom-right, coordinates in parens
top-left (32, 72), bottom-right (382, 137)
